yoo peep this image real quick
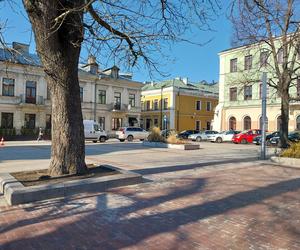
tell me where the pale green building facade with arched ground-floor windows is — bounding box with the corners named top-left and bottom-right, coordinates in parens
top-left (214, 41), bottom-right (300, 131)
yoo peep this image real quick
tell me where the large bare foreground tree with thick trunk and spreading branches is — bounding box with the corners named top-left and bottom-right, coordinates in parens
top-left (19, 0), bottom-right (219, 176)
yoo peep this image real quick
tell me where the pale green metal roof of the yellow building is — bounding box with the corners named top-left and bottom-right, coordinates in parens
top-left (142, 78), bottom-right (219, 94)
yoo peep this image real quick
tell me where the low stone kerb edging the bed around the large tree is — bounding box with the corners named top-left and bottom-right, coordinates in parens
top-left (0, 165), bottom-right (142, 205)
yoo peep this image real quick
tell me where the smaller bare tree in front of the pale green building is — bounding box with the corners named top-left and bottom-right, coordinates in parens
top-left (230, 0), bottom-right (300, 147)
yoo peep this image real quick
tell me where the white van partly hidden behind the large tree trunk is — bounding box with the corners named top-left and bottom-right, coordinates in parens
top-left (83, 120), bottom-right (108, 142)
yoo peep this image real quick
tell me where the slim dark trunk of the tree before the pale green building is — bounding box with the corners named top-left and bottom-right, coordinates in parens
top-left (280, 88), bottom-right (290, 148)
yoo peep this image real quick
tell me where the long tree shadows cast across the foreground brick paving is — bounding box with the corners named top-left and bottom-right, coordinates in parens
top-left (1, 175), bottom-right (300, 249)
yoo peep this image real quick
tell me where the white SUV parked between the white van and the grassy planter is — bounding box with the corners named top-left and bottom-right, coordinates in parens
top-left (116, 127), bottom-right (149, 142)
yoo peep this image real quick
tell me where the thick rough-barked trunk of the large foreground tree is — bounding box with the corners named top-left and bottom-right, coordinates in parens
top-left (23, 0), bottom-right (87, 176)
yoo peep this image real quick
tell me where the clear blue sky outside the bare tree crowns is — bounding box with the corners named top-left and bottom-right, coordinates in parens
top-left (0, 0), bottom-right (231, 82)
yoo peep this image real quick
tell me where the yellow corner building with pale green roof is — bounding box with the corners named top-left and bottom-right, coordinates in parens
top-left (141, 78), bottom-right (218, 131)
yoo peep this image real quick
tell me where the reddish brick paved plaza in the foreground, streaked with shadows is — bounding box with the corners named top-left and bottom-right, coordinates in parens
top-left (0, 154), bottom-right (300, 250)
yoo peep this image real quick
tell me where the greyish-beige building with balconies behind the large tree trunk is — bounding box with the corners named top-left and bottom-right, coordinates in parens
top-left (0, 43), bottom-right (143, 134)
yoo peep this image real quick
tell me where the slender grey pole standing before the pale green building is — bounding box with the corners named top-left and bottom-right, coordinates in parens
top-left (260, 72), bottom-right (267, 160)
